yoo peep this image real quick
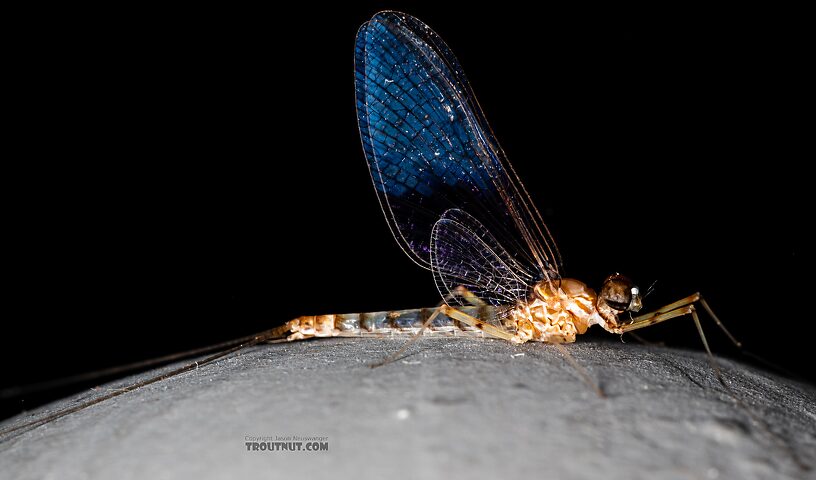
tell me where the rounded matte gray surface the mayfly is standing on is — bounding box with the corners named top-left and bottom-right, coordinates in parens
top-left (0, 338), bottom-right (816, 480)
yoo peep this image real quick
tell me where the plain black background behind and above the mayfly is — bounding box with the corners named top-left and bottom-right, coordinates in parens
top-left (0, 2), bottom-right (814, 414)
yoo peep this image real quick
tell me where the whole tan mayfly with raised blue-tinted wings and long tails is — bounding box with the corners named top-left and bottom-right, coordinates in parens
top-left (0, 11), bottom-right (764, 442)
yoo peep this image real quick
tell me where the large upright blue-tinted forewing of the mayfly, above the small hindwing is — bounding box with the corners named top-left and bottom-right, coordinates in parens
top-left (355, 12), bottom-right (559, 308)
